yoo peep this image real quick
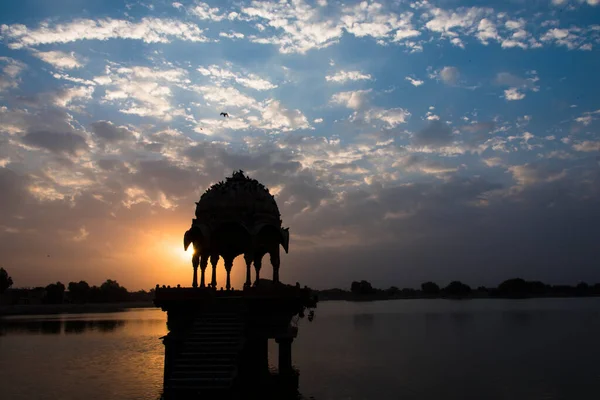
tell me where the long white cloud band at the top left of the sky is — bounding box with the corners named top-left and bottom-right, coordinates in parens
top-left (0, 18), bottom-right (208, 49)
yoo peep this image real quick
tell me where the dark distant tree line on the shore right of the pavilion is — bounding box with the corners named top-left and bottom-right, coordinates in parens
top-left (318, 278), bottom-right (600, 301)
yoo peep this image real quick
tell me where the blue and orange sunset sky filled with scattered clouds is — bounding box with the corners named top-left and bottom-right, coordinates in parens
top-left (0, 0), bottom-right (600, 290)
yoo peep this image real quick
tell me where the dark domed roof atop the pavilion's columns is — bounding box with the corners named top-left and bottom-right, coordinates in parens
top-left (196, 170), bottom-right (281, 225)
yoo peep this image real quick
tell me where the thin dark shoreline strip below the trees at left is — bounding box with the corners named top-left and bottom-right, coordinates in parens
top-left (0, 301), bottom-right (156, 317)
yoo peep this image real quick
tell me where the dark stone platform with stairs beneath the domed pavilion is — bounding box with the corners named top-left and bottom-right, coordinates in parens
top-left (154, 281), bottom-right (317, 400)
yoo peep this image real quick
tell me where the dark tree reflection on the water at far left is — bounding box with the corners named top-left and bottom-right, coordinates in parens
top-left (0, 319), bottom-right (126, 335)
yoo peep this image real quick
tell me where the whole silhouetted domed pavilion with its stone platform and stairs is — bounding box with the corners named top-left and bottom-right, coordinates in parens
top-left (154, 171), bottom-right (317, 400)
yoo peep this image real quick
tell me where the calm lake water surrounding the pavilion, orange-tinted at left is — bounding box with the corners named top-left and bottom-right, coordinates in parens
top-left (0, 298), bottom-right (600, 400)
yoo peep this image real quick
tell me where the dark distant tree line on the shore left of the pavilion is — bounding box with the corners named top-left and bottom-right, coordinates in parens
top-left (0, 268), bottom-right (154, 304)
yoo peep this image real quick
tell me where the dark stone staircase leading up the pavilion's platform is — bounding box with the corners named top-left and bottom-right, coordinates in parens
top-left (168, 312), bottom-right (245, 399)
